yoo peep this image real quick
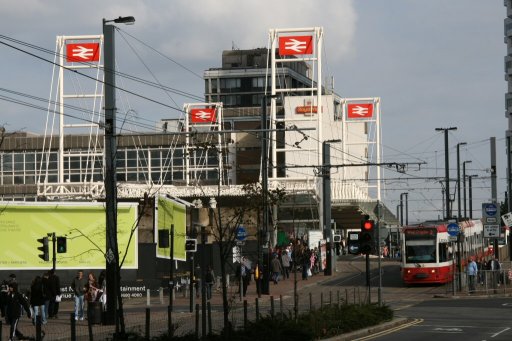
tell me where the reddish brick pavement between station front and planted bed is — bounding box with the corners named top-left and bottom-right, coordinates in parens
top-left (2, 258), bottom-right (408, 341)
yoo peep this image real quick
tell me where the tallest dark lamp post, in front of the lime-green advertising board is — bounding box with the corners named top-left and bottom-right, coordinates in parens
top-left (103, 17), bottom-right (135, 330)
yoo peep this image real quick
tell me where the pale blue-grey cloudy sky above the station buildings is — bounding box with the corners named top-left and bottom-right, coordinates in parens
top-left (0, 0), bottom-right (508, 222)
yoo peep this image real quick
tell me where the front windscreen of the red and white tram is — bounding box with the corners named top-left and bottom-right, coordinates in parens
top-left (405, 229), bottom-right (437, 263)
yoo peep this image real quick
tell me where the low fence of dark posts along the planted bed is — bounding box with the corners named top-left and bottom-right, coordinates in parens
top-left (0, 288), bottom-right (367, 341)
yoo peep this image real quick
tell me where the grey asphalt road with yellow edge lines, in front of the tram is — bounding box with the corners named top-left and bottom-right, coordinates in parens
top-left (323, 257), bottom-right (512, 341)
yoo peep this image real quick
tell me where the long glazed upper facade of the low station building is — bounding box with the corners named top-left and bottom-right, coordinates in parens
top-left (0, 147), bottom-right (227, 185)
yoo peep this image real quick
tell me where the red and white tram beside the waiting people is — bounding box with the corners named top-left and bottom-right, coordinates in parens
top-left (401, 220), bottom-right (492, 285)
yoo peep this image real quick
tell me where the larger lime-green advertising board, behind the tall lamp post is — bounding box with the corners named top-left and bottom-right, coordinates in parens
top-left (0, 202), bottom-right (138, 270)
